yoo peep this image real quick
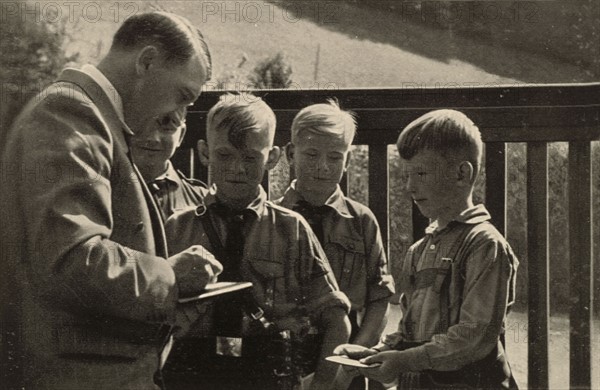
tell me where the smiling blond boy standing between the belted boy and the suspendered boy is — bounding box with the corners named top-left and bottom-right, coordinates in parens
top-left (275, 100), bottom-right (394, 388)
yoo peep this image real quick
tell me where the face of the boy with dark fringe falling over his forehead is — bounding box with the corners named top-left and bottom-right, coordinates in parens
top-left (208, 131), bottom-right (271, 203)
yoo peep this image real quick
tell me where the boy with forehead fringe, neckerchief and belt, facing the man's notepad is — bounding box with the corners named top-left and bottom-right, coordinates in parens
top-left (167, 94), bottom-right (350, 389)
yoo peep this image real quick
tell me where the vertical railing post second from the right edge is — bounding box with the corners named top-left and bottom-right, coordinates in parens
top-left (527, 142), bottom-right (549, 389)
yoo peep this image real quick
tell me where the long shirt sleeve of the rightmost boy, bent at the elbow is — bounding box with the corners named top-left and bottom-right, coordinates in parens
top-left (386, 235), bottom-right (516, 371)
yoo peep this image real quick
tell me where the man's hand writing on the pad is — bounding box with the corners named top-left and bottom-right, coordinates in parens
top-left (167, 245), bottom-right (223, 297)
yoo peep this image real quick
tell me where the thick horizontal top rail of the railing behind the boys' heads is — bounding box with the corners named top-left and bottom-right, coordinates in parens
top-left (184, 83), bottom-right (600, 147)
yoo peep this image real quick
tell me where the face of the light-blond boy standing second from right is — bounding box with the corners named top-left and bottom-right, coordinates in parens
top-left (293, 131), bottom-right (350, 195)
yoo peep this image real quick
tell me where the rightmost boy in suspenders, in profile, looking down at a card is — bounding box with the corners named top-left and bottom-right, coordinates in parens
top-left (336, 110), bottom-right (518, 389)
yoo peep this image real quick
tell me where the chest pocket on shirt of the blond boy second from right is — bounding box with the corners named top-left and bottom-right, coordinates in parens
top-left (325, 236), bottom-right (367, 295)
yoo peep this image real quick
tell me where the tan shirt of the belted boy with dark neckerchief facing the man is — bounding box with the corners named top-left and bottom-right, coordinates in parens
top-left (166, 187), bottom-right (350, 322)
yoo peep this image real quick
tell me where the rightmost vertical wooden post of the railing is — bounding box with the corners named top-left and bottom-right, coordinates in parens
top-left (569, 141), bottom-right (593, 389)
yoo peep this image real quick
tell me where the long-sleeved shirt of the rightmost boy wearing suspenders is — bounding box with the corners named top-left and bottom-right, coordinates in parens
top-left (383, 205), bottom-right (519, 371)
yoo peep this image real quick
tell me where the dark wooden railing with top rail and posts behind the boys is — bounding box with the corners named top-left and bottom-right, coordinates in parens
top-left (174, 83), bottom-right (600, 388)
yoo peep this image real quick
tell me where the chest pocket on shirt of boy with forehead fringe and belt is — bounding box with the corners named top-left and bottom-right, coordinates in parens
top-left (249, 259), bottom-right (286, 311)
